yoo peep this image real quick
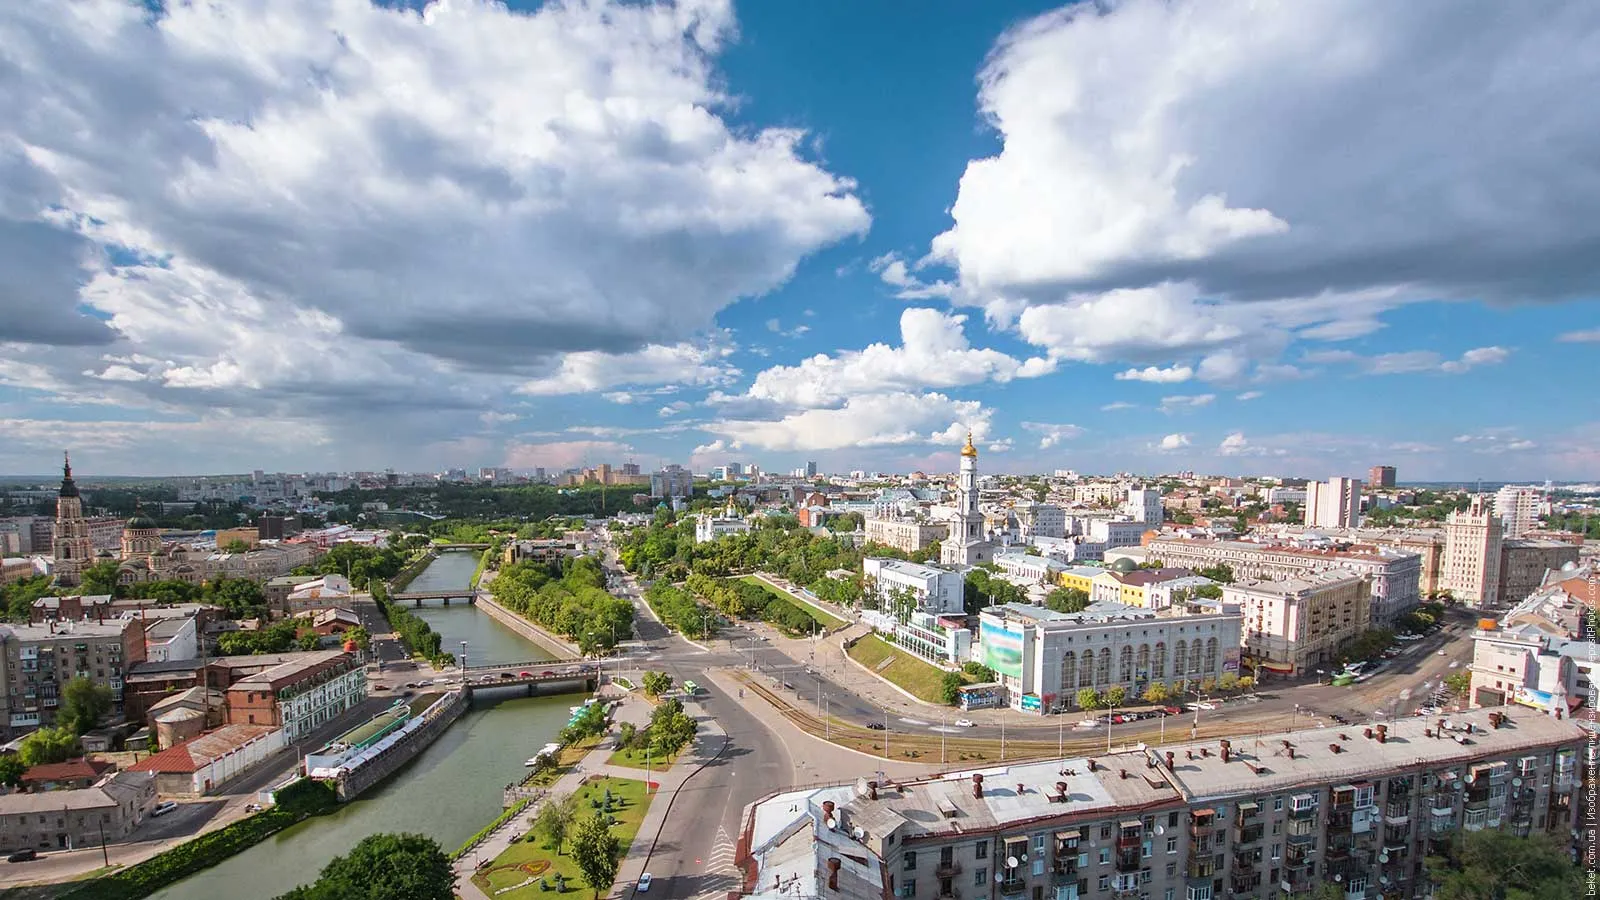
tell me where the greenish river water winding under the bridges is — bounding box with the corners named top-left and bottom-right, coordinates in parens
top-left (154, 552), bottom-right (574, 900)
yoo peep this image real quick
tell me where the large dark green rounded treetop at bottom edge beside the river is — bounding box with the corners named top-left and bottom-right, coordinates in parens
top-left (280, 833), bottom-right (456, 900)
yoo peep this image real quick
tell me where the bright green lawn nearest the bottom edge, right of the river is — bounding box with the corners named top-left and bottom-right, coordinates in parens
top-left (472, 778), bottom-right (651, 900)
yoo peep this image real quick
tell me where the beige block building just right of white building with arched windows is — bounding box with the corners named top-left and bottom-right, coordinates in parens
top-left (1222, 572), bottom-right (1371, 674)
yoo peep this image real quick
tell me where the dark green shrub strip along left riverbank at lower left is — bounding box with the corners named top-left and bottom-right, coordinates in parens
top-left (59, 778), bottom-right (338, 900)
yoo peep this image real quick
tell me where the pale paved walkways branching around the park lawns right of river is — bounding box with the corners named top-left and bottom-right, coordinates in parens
top-left (454, 700), bottom-right (728, 900)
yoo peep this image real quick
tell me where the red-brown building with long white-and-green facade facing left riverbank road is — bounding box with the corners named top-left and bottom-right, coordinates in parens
top-left (226, 650), bottom-right (366, 743)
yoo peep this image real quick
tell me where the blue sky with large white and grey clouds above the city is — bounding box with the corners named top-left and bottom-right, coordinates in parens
top-left (0, 0), bottom-right (1600, 480)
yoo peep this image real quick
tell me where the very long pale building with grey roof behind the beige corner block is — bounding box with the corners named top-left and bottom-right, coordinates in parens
top-left (1146, 538), bottom-right (1422, 625)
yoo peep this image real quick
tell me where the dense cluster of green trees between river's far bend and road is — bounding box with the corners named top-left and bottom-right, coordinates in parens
top-left (490, 557), bottom-right (634, 655)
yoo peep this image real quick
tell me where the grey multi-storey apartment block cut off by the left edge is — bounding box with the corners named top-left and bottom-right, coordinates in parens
top-left (0, 618), bottom-right (144, 738)
